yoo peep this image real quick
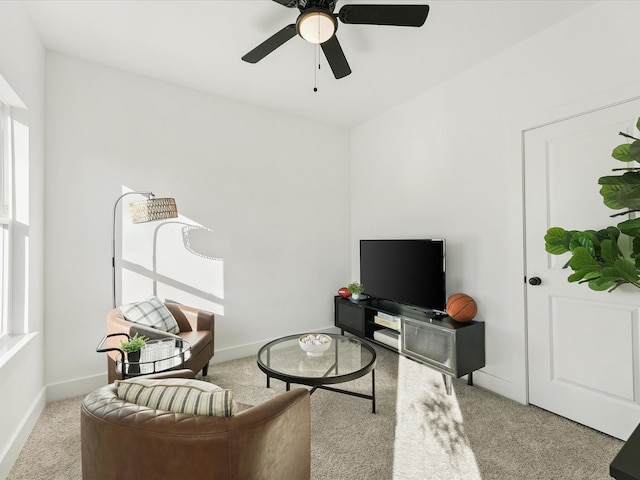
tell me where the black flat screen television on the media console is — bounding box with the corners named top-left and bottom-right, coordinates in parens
top-left (360, 239), bottom-right (446, 311)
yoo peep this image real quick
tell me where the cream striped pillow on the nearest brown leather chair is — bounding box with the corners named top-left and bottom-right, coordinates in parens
top-left (116, 377), bottom-right (238, 417)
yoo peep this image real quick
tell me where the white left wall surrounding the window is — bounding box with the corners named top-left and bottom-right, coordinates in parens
top-left (0, 2), bottom-right (45, 478)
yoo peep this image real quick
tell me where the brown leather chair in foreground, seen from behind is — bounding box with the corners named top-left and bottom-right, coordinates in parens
top-left (80, 371), bottom-right (311, 480)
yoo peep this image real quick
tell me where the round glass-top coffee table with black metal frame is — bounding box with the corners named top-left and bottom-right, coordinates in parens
top-left (257, 333), bottom-right (376, 413)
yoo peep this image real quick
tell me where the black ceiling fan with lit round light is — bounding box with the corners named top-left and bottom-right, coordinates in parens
top-left (242, 0), bottom-right (429, 78)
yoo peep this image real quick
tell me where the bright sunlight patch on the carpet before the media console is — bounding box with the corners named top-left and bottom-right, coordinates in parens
top-left (393, 356), bottom-right (482, 480)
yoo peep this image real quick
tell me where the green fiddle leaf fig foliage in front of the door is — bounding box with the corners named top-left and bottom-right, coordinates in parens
top-left (544, 118), bottom-right (640, 291)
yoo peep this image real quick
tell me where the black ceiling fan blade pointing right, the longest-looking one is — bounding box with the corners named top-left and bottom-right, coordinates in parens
top-left (338, 5), bottom-right (429, 27)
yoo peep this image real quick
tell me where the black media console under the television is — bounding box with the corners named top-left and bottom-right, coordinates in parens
top-left (334, 296), bottom-right (485, 394)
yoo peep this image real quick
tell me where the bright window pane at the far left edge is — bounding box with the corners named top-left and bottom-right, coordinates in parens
top-left (0, 99), bottom-right (13, 339)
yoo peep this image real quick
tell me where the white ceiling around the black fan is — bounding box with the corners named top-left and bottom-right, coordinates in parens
top-left (25, 0), bottom-right (594, 127)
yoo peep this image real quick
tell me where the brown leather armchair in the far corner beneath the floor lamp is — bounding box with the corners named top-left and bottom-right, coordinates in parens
top-left (107, 303), bottom-right (215, 383)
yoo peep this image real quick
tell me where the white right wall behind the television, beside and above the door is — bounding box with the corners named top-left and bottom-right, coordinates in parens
top-left (351, 1), bottom-right (640, 402)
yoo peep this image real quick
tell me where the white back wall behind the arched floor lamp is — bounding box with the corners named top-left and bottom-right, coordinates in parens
top-left (45, 54), bottom-right (350, 397)
